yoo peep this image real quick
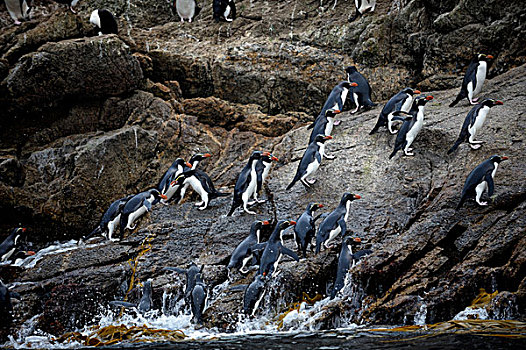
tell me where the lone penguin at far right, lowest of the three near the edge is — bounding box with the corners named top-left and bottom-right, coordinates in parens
top-left (456, 155), bottom-right (508, 210)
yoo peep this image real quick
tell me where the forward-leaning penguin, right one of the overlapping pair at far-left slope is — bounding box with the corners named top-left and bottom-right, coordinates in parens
top-left (120, 188), bottom-right (167, 238)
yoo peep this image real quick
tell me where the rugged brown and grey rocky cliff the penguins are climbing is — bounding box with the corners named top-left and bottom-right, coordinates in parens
top-left (0, 0), bottom-right (526, 340)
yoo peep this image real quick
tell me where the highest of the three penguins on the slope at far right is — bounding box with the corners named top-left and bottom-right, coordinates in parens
top-left (449, 54), bottom-right (493, 107)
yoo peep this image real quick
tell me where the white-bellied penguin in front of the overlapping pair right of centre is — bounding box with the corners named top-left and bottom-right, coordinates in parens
top-left (389, 96), bottom-right (433, 159)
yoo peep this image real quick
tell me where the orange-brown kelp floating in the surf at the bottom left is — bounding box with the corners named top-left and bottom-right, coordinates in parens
top-left (53, 325), bottom-right (186, 346)
